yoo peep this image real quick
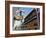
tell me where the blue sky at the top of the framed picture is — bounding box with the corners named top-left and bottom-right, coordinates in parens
top-left (13, 7), bottom-right (33, 17)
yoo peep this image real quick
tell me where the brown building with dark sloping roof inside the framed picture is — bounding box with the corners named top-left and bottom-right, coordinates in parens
top-left (21, 9), bottom-right (40, 30)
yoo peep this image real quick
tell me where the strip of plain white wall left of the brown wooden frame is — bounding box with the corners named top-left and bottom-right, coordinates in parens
top-left (0, 0), bottom-right (5, 37)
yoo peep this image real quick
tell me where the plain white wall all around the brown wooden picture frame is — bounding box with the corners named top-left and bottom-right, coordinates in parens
top-left (0, 0), bottom-right (46, 38)
